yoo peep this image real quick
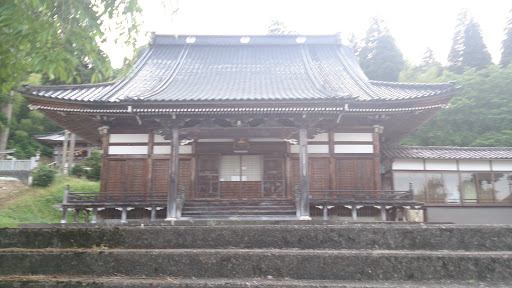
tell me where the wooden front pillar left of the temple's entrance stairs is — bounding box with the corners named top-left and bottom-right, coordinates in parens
top-left (165, 127), bottom-right (180, 221)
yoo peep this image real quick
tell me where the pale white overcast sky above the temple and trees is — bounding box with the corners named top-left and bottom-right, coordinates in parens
top-left (102, 0), bottom-right (512, 68)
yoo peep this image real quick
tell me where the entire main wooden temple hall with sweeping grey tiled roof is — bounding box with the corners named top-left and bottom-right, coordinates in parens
top-left (21, 35), bottom-right (468, 221)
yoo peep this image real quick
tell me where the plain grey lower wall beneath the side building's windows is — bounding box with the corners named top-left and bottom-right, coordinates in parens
top-left (427, 207), bottom-right (512, 224)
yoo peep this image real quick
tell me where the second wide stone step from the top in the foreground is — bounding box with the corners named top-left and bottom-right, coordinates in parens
top-left (0, 249), bottom-right (512, 282)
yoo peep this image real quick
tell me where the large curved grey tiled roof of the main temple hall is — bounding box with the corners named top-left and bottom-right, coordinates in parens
top-left (23, 35), bottom-right (456, 103)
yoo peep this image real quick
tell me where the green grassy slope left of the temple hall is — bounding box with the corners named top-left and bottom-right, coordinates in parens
top-left (0, 176), bottom-right (100, 227)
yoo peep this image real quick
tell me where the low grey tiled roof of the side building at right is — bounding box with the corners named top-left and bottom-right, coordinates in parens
top-left (382, 146), bottom-right (512, 160)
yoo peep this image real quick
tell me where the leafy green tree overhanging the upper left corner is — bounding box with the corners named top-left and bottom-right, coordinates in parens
top-left (0, 0), bottom-right (141, 94)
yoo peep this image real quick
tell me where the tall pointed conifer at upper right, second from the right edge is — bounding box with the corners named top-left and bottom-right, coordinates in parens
top-left (448, 9), bottom-right (492, 74)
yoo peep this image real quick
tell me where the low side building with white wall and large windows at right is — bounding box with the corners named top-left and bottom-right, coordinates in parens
top-left (382, 146), bottom-right (512, 224)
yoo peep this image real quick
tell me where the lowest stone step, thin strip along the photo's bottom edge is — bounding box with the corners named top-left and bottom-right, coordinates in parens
top-left (0, 276), bottom-right (510, 288)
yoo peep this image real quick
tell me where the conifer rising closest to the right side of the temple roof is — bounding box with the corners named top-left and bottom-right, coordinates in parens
top-left (359, 18), bottom-right (405, 81)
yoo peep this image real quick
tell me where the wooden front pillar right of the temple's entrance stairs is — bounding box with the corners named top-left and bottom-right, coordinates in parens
top-left (299, 128), bottom-right (311, 220)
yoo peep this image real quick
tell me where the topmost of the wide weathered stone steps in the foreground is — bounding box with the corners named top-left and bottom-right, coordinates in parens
top-left (0, 224), bottom-right (512, 251)
